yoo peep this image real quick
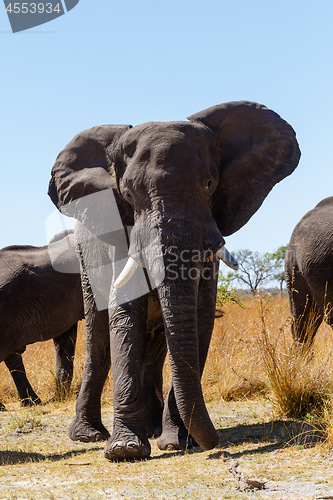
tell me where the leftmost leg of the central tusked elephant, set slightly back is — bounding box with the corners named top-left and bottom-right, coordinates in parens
top-left (68, 306), bottom-right (110, 443)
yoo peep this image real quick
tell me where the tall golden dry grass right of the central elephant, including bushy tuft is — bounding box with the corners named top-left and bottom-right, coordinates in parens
top-left (204, 295), bottom-right (333, 418)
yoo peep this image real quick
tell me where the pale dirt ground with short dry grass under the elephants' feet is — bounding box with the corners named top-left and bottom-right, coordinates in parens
top-left (0, 399), bottom-right (333, 500)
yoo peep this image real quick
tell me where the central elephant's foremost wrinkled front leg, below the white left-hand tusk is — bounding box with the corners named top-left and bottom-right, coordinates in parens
top-left (104, 296), bottom-right (151, 460)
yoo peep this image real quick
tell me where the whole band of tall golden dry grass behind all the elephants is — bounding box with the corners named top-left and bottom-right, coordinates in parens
top-left (0, 296), bottom-right (333, 426)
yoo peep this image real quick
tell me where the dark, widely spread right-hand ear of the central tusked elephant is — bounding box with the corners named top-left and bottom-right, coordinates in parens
top-left (188, 101), bottom-right (301, 236)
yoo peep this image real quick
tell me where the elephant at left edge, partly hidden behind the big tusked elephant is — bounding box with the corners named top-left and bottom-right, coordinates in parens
top-left (0, 231), bottom-right (84, 406)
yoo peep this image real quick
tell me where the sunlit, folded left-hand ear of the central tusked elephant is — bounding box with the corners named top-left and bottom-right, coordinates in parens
top-left (48, 125), bottom-right (132, 224)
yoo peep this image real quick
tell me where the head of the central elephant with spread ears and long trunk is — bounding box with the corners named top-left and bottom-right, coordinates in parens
top-left (49, 102), bottom-right (300, 449)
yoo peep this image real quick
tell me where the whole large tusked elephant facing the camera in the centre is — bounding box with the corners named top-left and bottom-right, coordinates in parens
top-left (49, 102), bottom-right (300, 460)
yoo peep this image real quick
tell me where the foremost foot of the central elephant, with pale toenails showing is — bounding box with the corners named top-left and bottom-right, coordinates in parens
top-left (104, 426), bottom-right (151, 462)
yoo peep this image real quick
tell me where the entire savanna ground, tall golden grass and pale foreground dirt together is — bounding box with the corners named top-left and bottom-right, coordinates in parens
top-left (0, 297), bottom-right (333, 500)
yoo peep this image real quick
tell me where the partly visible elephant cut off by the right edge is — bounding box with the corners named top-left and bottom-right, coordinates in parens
top-left (285, 197), bottom-right (333, 346)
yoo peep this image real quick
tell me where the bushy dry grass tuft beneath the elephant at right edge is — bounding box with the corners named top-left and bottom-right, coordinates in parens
top-left (259, 297), bottom-right (333, 419)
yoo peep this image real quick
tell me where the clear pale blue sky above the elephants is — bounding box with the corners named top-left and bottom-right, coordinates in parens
top-left (0, 0), bottom-right (333, 252)
